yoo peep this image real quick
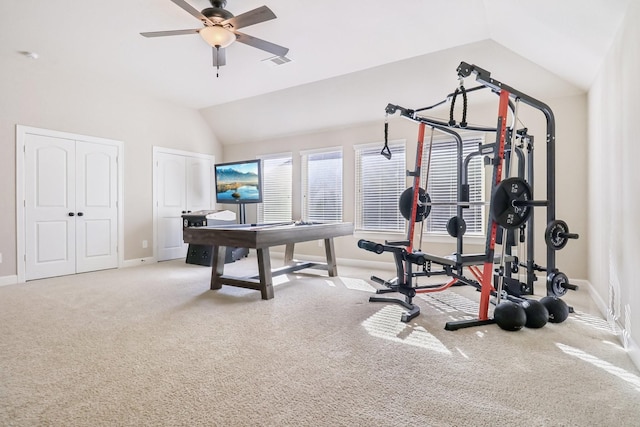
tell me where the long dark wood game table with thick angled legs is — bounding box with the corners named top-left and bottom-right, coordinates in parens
top-left (182, 222), bottom-right (353, 299)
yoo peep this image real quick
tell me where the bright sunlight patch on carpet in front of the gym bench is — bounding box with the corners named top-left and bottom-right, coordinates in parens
top-left (362, 305), bottom-right (451, 354)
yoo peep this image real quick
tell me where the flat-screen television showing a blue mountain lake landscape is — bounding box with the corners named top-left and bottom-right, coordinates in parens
top-left (215, 159), bottom-right (262, 204)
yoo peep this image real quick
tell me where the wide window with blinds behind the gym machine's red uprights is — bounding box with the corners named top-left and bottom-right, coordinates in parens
top-left (420, 134), bottom-right (485, 235)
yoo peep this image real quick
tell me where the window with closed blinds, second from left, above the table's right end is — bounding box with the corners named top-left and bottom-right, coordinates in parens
top-left (301, 148), bottom-right (342, 222)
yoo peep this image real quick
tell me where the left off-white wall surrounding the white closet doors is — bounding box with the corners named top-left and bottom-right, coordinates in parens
top-left (0, 55), bottom-right (222, 278)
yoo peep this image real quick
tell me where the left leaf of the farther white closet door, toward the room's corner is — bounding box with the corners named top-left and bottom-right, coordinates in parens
top-left (156, 153), bottom-right (188, 261)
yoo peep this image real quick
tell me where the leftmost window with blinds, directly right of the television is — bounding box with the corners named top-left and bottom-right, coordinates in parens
top-left (258, 153), bottom-right (292, 223)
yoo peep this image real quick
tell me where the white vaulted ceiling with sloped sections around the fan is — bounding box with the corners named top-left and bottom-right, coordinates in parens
top-left (0, 0), bottom-right (632, 143)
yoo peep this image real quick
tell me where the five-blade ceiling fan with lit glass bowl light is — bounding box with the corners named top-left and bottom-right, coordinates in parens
top-left (140, 0), bottom-right (289, 75)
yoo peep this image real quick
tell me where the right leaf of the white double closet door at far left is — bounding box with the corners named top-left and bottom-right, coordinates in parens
top-left (76, 142), bottom-right (118, 273)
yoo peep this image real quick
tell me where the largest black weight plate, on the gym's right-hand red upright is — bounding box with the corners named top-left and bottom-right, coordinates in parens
top-left (491, 177), bottom-right (532, 229)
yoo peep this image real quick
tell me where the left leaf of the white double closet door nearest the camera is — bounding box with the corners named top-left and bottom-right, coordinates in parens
top-left (25, 134), bottom-right (76, 280)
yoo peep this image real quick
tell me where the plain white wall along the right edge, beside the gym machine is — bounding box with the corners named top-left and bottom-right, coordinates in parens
top-left (589, 2), bottom-right (640, 366)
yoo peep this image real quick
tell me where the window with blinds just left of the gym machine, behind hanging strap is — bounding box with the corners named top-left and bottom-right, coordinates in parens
top-left (355, 142), bottom-right (407, 233)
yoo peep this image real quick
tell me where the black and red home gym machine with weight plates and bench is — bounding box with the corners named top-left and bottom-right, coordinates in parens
top-left (358, 62), bottom-right (579, 330)
